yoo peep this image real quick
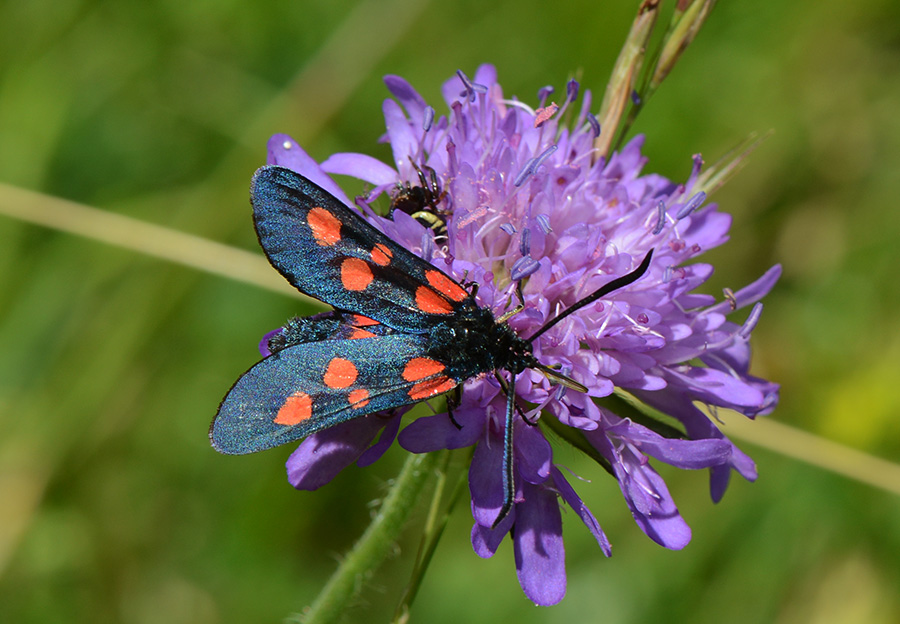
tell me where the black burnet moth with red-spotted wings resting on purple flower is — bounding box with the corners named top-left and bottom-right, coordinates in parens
top-left (209, 166), bottom-right (653, 526)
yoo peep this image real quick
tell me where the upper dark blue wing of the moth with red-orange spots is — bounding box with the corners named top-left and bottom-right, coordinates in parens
top-left (251, 166), bottom-right (475, 333)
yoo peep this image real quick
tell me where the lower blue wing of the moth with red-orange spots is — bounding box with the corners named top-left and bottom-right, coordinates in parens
top-left (209, 334), bottom-right (461, 454)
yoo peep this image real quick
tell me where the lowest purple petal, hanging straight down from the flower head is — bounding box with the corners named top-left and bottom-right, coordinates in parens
top-left (513, 484), bottom-right (566, 606)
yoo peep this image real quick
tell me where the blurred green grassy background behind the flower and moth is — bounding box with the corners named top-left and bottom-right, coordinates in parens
top-left (0, 0), bottom-right (900, 624)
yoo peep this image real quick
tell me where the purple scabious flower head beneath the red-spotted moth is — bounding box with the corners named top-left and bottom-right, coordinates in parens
top-left (264, 65), bottom-right (780, 605)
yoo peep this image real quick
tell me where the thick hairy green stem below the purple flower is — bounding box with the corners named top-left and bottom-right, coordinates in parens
top-left (292, 453), bottom-right (437, 624)
